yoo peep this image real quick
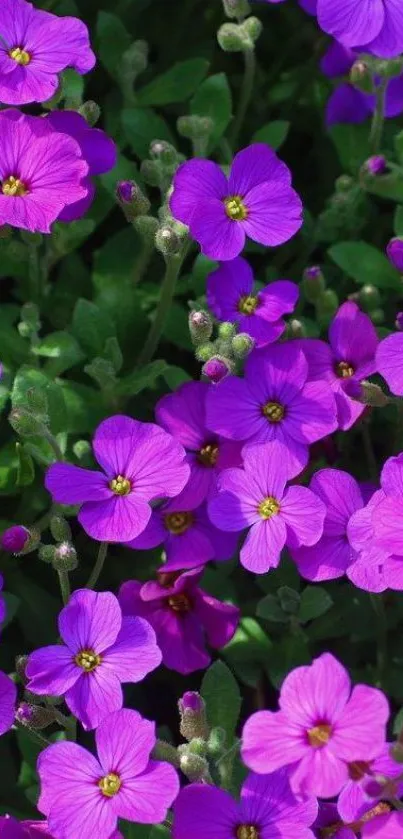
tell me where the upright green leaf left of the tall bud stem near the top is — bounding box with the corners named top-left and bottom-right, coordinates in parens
top-left (190, 73), bottom-right (232, 151)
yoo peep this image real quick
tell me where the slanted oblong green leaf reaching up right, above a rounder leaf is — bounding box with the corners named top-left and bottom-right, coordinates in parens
top-left (136, 58), bottom-right (209, 105)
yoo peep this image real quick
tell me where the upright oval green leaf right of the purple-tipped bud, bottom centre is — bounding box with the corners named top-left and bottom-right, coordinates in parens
top-left (200, 661), bottom-right (242, 744)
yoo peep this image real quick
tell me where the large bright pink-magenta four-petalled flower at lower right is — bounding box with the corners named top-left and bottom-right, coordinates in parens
top-left (242, 653), bottom-right (389, 798)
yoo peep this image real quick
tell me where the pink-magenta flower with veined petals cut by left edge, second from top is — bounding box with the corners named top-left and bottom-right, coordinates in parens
top-left (0, 109), bottom-right (88, 233)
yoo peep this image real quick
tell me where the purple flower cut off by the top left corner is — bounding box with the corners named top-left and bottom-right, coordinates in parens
top-left (0, 0), bottom-right (95, 105)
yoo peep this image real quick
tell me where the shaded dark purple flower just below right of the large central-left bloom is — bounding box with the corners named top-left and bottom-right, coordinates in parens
top-left (126, 488), bottom-right (238, 573)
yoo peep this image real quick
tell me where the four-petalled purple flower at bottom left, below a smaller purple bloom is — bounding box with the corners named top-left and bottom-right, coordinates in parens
top-left (37, 709), bottom-right (179, 839)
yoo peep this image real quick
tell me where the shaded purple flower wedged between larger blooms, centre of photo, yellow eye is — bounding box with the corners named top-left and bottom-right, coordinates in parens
top-left (155, 382), bottom-right (242, 504)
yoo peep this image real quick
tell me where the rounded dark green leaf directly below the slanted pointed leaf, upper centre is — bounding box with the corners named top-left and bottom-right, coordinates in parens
top-left (121, 108), bottom-right (174, 160)
